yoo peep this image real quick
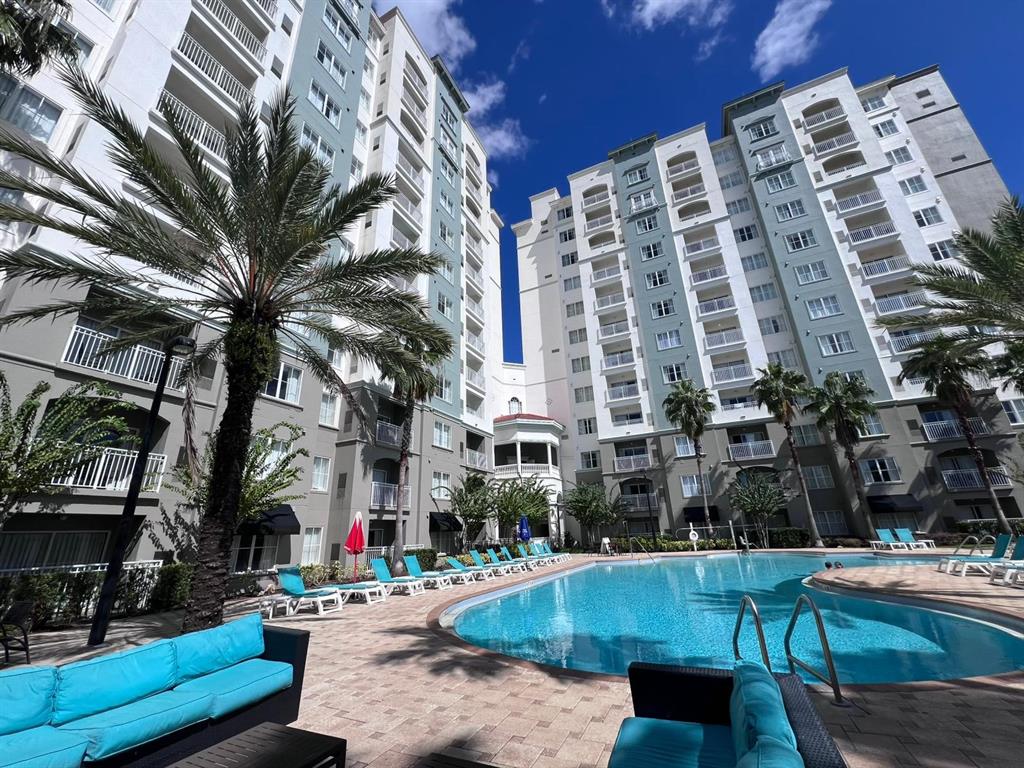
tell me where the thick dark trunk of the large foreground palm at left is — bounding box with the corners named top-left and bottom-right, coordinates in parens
top-left (182, 323), bottom-right (278, 632)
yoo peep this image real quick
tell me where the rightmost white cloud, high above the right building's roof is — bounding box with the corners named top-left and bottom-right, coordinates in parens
top-left (751, 0), bottom-right (831, 82)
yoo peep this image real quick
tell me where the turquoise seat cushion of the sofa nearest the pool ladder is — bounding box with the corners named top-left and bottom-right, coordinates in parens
top-left (608, 718), bottom-right (736, 768)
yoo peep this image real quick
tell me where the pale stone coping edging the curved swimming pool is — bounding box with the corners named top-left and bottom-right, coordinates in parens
top-left (425, 549), bottom-right (1024, 693)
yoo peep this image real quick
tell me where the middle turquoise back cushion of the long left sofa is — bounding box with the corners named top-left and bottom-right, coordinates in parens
top-left (50, 640), bottom-right (176, 725)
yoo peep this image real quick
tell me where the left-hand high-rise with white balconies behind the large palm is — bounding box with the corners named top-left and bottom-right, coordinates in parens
top-left (0, 0), bottom-right (502, 570)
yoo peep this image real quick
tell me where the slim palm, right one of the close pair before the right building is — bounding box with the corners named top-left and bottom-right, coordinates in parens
top-left (804, 371), bottom-right (878, 540)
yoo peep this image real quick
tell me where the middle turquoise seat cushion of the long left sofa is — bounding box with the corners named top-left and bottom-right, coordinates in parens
top-left (59, 690), bottom-right (213, 760)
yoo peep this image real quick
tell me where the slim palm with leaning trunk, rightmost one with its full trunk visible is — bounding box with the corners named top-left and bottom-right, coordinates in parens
top-left (899, 336), bottom-right (1013, 534)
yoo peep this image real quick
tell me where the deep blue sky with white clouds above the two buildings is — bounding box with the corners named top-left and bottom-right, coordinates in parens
top-left (375, 0), bottom-right (1024, 361)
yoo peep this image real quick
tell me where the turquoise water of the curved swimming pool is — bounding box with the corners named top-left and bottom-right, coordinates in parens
top-left (454, 555), bottom-right (1024, 683)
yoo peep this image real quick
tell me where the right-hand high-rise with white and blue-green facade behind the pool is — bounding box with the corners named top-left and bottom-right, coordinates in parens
top-left (513, 68), bottom-right (1024, 535)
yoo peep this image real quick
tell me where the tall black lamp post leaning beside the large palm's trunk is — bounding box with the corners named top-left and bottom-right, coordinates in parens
top-left (89, 336), bottom-right (196, 645)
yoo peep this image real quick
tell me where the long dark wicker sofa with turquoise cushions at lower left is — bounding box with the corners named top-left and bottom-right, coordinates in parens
top-left (0, 613), bottom-right (309, 768)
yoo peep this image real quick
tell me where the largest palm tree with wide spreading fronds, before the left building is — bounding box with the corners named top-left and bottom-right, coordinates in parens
top-left (0, 70), bottom-right (452, 631)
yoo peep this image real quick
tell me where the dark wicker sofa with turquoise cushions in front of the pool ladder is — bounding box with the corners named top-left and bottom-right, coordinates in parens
top-left (608, 662), bottom-right (846, 768)
